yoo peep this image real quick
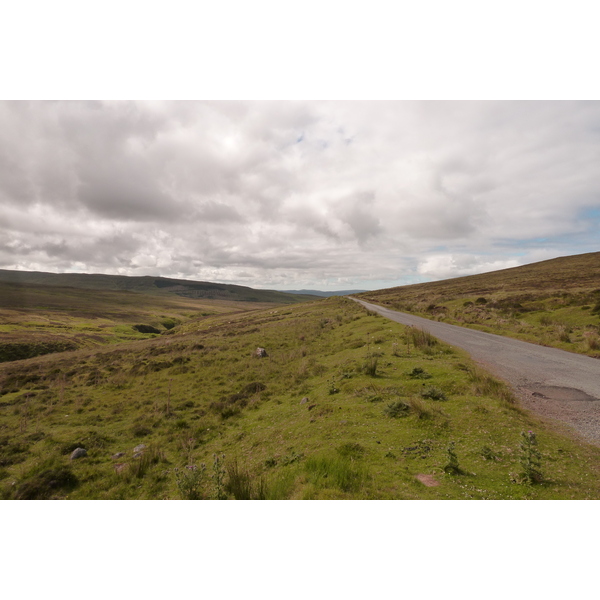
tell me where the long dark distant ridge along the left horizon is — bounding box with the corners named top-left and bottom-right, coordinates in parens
top-left (0, 269), bottom-right (316, 304)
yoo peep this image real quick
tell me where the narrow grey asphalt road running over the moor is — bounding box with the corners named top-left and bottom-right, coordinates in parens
top-left (353, 298), bottom-right (600, 445)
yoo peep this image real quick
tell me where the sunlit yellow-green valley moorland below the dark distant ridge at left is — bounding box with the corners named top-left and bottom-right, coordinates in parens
top-left (0, 278), bottom-right (306, 362)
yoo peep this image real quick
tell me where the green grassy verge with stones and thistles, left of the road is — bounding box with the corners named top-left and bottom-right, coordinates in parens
top-left (0, 298), bottom-right (600, 499)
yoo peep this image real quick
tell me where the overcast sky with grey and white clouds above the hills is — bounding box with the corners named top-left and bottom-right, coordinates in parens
top-left (0, 101), bottom-right (600, 290)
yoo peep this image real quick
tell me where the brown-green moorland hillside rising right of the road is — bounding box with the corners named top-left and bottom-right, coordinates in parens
top-left (358, 252), bottom-right (600, 357)
